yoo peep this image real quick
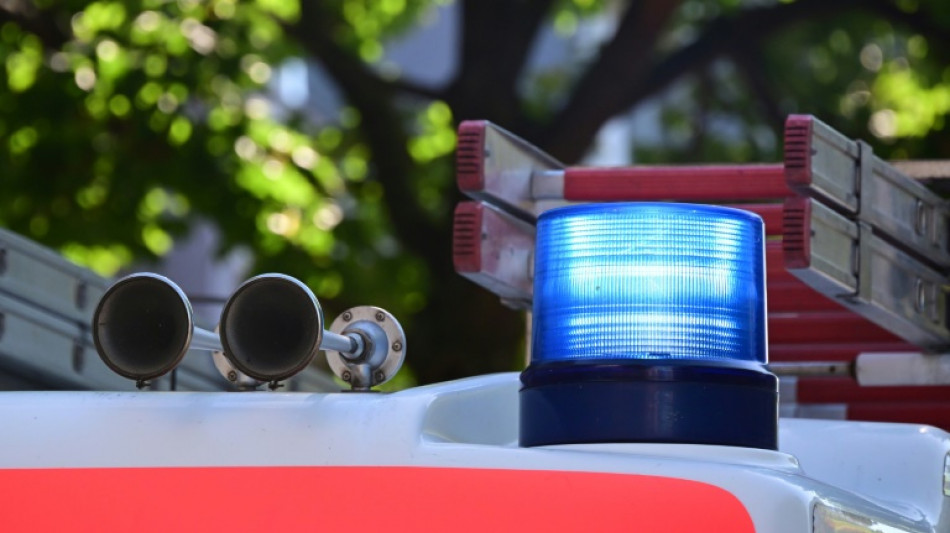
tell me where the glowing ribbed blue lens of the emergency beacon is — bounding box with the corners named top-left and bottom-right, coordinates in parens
top-left (532, 203), bottom-right (767, 363)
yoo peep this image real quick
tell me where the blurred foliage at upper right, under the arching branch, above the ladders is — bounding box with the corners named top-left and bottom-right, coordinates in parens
top-left (633, 0), bottom-right (950, 162)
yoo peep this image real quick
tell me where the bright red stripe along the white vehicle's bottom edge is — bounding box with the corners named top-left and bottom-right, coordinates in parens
top-left (0, 467), bottom-right (755, 533)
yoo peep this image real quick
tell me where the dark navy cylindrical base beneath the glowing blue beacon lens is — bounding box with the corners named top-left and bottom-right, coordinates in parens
top-left (519, 360), bottom-right (778, 450)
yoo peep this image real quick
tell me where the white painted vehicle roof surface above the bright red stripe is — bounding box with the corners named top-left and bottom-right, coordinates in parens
top-left (0, 374), bottom-right (950, 533)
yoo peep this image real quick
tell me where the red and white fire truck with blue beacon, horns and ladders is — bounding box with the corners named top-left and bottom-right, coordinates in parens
top-left (0, 115), bottom-right (950, 533)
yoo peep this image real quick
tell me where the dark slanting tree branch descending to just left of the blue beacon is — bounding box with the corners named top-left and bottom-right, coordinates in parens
top-left (288, 2), bottom-right (522, 383)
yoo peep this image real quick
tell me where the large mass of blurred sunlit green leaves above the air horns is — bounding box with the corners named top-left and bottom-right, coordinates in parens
top-left (0, 0), bottom-right (454, 374)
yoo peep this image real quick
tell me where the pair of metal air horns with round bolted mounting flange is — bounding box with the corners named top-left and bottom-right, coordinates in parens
top-left (93, 273), bottom-right (405, 390)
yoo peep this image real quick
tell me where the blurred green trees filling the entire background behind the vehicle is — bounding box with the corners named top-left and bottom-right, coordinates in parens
top-left (0, 0), bottom-right (950, 382)
